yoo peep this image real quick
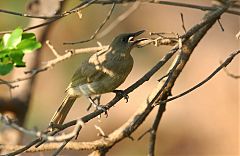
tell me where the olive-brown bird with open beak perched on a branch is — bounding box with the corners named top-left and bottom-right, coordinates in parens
top-left (49, 30), bottom-right (144, 125)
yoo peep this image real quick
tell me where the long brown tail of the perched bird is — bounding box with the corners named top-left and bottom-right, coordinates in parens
top-left (50, 95), bottom-right (77, 125)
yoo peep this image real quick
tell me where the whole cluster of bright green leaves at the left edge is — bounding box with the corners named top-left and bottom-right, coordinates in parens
top-left (0, 28), bottom-right (41, 75)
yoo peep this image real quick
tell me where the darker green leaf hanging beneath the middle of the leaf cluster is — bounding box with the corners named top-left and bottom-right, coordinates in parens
top-left (9, 50), bottom-right (25, 67)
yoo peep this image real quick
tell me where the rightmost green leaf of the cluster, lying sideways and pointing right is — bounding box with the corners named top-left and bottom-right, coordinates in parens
top-left (17, 39), bottom-right (42, 53)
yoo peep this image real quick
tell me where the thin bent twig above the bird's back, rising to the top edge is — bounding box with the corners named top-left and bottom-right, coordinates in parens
top-left (63, 3), bottom-right (116, 44)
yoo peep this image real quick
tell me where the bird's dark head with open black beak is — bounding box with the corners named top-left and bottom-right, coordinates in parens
top-left (110, 30), bottom-right (145, 52)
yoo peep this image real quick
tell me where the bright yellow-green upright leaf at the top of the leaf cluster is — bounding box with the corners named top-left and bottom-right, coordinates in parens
top-left (3, 28), bottom-right (23, 49)
